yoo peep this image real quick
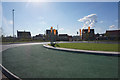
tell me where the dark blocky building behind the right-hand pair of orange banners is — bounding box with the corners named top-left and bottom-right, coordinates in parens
top-left (82, 29), bottom-right (95, 40)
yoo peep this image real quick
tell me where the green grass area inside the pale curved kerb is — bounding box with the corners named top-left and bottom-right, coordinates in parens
top-left (52, 43), bottom-right (120, 52)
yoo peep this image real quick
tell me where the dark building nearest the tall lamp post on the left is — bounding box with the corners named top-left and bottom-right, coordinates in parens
top-left (17, 30), bottom-right (31, 39)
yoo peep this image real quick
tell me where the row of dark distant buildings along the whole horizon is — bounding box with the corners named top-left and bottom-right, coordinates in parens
top-left (2, 29), bottom-right (120, 42)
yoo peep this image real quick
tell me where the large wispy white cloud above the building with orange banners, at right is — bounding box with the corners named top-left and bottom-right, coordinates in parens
top-left (78, 14), bottom-right (97, 29)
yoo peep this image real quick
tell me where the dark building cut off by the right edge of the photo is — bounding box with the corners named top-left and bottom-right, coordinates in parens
top-left (106, 30), bottom-right (120, 40)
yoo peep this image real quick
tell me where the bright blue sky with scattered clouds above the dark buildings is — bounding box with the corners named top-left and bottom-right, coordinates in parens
top-left (2, 2), bottom-right (118, 36)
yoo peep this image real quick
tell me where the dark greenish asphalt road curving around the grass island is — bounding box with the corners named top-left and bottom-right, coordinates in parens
top-left (2, 43), bottom-right (118, 78)
